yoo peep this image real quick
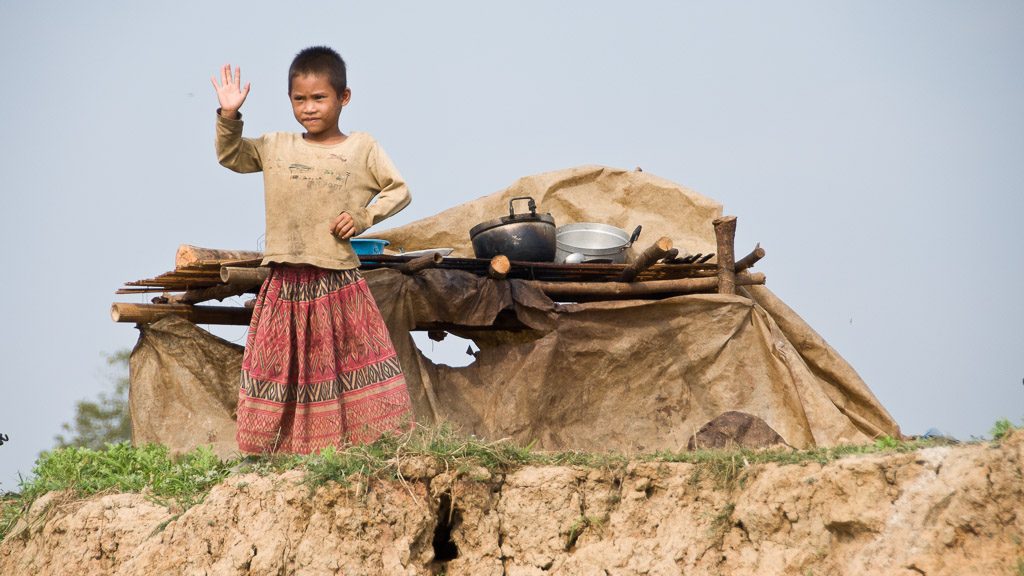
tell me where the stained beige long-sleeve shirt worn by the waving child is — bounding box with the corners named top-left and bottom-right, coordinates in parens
top-left (216, 114), bottom-right (410, 270)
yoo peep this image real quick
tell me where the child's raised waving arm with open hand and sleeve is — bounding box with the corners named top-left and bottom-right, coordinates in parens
top-left (210, 65), bottom-right (263, 172)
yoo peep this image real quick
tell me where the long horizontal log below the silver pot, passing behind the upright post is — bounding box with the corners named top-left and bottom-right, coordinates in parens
top-left (531, 273), bottom-right (765, 301)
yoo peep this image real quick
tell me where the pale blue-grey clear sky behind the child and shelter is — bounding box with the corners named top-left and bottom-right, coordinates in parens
top-left (0, 0), bottom-right (1024, 490)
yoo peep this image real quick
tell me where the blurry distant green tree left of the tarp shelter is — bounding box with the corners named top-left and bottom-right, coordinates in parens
top-left (54, 348), bottom-right (131, 450)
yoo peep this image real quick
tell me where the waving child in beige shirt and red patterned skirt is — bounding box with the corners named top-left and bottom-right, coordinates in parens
top-left (210, 47), bottom-right (413, 454)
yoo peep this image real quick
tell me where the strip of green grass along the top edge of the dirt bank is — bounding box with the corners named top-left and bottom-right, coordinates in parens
top-left (0, 425), bottom-right (994, 539)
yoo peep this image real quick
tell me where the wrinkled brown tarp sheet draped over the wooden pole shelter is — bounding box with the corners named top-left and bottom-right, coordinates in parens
top-left (131, 167), bottom-right (899, 455)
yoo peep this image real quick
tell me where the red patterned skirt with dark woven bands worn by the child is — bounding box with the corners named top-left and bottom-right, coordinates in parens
top-left (238, 265), bottom-right (413, 454)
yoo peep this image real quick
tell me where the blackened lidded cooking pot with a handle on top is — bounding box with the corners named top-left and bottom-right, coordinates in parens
top-left (469, 196), bottom-right (555, 262)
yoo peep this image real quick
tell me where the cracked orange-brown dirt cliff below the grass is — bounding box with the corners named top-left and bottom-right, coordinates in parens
top-left (0, 431), bottom-right (1024, 576)
